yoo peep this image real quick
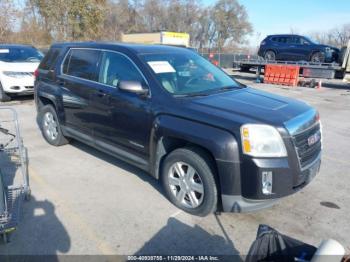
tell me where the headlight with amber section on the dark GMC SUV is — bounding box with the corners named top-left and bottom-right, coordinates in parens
top-left (241, 124), bottom-right (287, 157)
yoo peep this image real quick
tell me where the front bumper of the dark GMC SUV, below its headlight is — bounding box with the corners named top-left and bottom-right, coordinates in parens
top-left (221, 154), bottom-right (321, 212)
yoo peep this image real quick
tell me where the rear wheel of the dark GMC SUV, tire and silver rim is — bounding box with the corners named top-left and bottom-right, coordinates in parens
top-left (39, 105), bottom-right (69, 146)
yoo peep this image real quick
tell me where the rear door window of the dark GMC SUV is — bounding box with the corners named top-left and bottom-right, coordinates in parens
top-left (63, 49), bottom-right (101, 81)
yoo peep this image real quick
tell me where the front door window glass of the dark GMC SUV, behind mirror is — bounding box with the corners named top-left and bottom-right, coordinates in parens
top-left (98, 51), bottom-right (144, 87)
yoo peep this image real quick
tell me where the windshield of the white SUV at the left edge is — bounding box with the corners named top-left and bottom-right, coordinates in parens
top-left (0, 47), bottom-right (44, 63)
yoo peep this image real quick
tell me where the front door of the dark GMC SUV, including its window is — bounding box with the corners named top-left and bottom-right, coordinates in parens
top-left (91, 51), bottom-right (152, 162)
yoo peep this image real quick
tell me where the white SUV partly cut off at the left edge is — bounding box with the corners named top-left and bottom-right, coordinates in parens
top-left (0, 44), bottom-right (43, 102)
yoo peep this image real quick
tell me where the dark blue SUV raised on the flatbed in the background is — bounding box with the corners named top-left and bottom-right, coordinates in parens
top-left (258, 35), bottom-right (339, 63)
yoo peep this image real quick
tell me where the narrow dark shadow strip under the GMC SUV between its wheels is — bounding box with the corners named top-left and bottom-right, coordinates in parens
top-left (70, 140), bottom-right (165, 197)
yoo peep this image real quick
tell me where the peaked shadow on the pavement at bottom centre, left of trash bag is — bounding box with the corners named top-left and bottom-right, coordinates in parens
top-left (135, 217), bottom-right (242, 261)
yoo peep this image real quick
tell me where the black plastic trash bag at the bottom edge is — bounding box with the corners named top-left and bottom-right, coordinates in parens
top-left (245, 225), bottom-right (317, 262)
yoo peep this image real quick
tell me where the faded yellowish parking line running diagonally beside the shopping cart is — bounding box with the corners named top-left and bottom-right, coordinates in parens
top-left (28, 167), bottom-right (115, 255)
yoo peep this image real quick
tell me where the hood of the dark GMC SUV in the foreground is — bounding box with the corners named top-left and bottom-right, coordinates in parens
top-left (187, 88), bottom-right (311, 126)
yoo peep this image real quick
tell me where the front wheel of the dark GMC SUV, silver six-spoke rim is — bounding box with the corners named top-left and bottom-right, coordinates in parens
top-left (161, 148), bottom-right (218, 216)
